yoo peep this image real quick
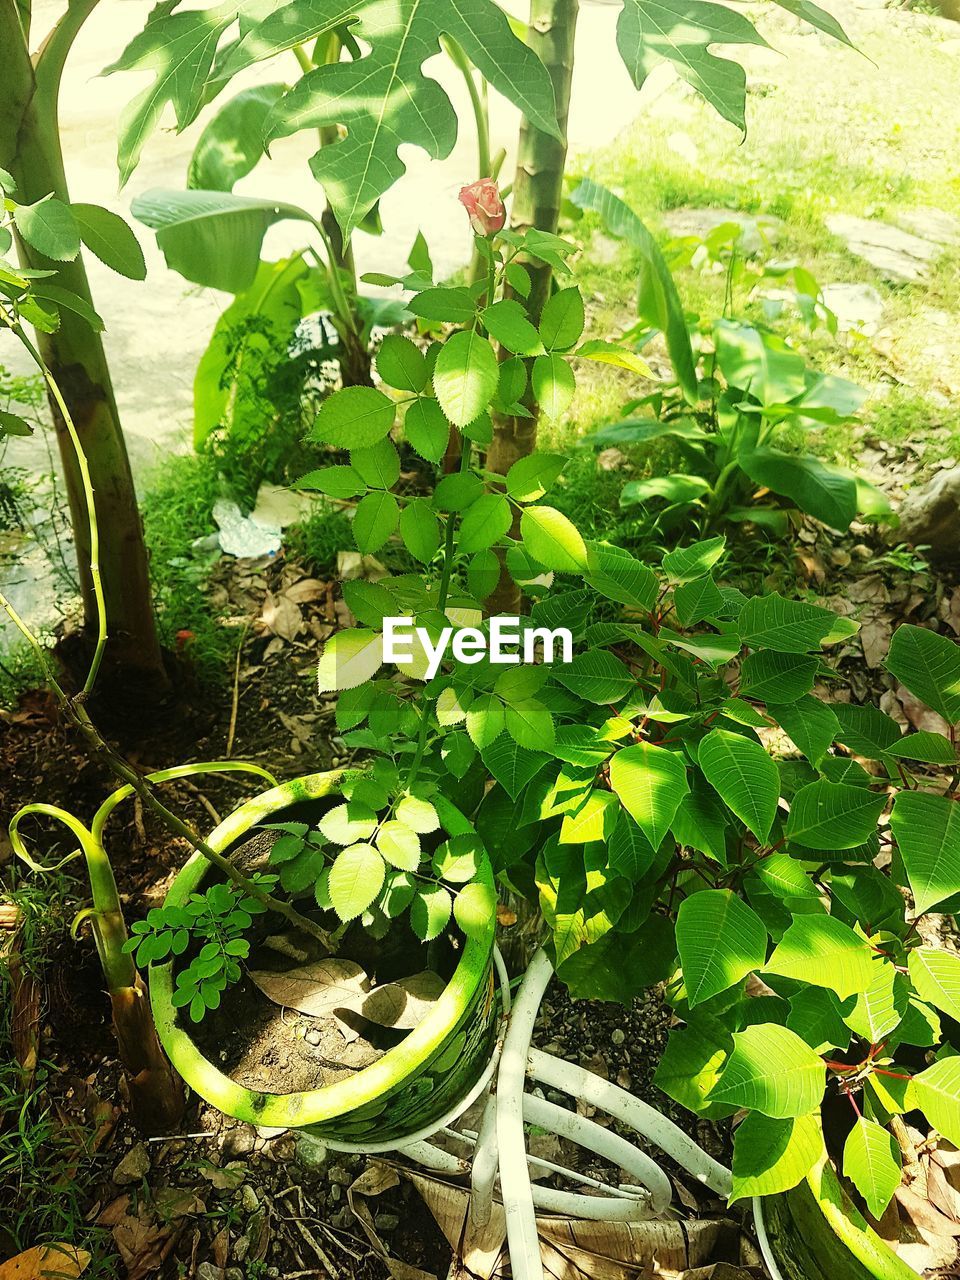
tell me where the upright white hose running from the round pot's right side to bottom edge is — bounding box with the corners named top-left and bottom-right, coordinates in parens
top-left (497, 948), bottom-right (553, 1280)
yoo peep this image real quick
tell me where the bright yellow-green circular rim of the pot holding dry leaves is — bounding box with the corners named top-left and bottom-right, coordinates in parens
top-left (148, 771), bottom-right (495, 1129)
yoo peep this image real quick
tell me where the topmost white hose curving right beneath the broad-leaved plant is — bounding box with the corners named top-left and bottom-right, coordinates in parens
top-left (529, 1036), bottom-right (732, 1196)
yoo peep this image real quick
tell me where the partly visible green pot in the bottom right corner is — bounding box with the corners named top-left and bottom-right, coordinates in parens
top-left (758, 1160), bottom-right (916, 1280)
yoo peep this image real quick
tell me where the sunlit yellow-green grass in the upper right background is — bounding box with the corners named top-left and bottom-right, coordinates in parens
top-left (554, 3), bottom-right (960, 462)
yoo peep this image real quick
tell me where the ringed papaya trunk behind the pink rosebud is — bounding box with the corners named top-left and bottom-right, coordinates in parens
top-left (486, 0), bottom-right (580, 614)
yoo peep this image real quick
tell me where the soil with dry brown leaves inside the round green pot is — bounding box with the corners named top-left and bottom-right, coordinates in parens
top-left (180, 815), bottom-right (463, 1093)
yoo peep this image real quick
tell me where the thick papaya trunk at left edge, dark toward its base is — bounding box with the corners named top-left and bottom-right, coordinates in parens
top-left (0, 0), bottom-right (166, 691)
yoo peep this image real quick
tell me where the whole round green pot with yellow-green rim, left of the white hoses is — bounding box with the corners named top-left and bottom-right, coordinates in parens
top-left (150, 773), bottom-right (497, 1147)
